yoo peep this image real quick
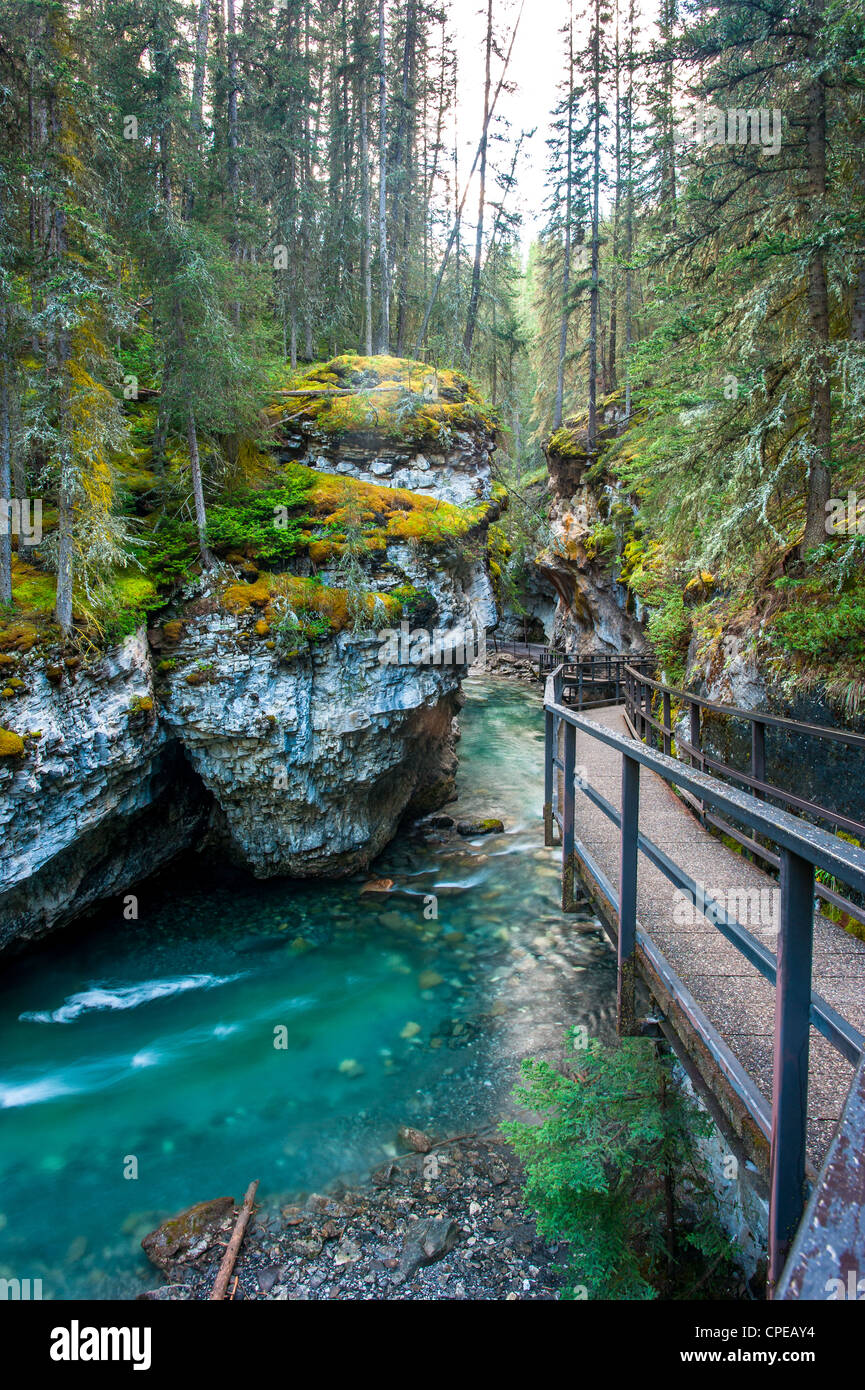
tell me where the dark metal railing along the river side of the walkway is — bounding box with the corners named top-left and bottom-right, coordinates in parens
top-left (544, 667), bottom-right (865, 1293)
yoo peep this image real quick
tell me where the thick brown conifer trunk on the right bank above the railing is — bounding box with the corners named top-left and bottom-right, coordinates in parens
top-left (800, 9), bottom-right (832, 556)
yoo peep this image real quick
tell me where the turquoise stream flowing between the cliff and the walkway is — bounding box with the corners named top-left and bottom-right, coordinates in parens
top-left (0, 680), bottom-right (612, 1298)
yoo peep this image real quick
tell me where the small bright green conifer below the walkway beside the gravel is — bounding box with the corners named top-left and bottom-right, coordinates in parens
top-left (502, 1038), bottom-right (730, 1300)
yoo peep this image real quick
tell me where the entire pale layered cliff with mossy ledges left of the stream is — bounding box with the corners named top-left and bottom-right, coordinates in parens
top-left (0, 353), bottom-right (496, 947)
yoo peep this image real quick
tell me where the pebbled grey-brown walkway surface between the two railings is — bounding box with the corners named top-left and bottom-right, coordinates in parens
top-left (576, 706), bottom-right (865, 1170)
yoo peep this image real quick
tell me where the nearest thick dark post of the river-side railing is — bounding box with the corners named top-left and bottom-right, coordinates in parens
top-left (769, 849), bottom-right (814, 1297)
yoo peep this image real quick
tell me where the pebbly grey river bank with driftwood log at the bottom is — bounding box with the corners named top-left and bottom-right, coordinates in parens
top-left (139, 1131), bottom-right (565, 1302)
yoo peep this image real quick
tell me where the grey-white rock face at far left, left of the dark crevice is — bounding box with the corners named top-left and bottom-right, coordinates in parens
top-left (0, 632), bottom-right (209, 947)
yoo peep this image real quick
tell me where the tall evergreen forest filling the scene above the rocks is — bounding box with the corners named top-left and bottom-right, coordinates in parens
top-left (0, 0), bottom-right (865, 695)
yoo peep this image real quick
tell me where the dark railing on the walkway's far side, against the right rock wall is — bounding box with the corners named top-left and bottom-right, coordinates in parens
top-left (624, 662), bottom-right (865, 923)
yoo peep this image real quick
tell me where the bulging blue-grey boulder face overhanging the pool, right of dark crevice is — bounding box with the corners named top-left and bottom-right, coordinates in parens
top-left (155, 613), bottom-right (464, 877)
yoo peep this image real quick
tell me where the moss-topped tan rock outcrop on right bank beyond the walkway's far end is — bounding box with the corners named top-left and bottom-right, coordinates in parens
top-left (537, 403), bottom-right (648, 656)
